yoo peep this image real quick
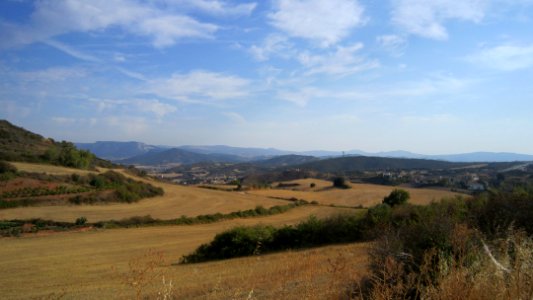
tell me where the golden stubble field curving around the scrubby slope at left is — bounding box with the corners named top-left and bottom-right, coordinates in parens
top-left (0, 163), bottom-right (287, 222)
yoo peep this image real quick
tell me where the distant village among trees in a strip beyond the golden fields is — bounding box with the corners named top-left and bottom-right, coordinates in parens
top-left (141, 164), bottom-right (533, 194)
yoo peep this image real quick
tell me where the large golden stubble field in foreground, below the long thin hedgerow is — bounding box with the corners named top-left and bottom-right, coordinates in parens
top-left (0, 206), bottom-right (364, 299)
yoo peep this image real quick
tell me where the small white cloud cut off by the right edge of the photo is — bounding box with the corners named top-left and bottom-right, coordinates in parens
top-left (467, 45), bottom-right (533, 71)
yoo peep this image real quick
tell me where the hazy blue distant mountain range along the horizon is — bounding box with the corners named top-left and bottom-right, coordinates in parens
top-left (76, 141), bottom-right (533, 164)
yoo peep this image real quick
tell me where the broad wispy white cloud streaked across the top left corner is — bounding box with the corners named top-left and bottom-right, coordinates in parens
top-left (0, 0), bottom-right (218, 48)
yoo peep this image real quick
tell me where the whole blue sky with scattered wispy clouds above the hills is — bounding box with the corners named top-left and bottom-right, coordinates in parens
top-left (0, 0), bottom-right (533, 154)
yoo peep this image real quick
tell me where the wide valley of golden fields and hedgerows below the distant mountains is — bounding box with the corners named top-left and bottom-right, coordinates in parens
top-left (0, 120), bottom-right (531, 299)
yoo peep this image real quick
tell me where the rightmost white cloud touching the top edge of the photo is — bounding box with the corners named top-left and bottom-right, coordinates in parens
top-left (392, 0), bottom-right (488, 40)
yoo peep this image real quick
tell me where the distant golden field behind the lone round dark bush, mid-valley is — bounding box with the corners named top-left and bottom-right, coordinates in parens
top-left (250, 179), bottom-right (464, 207)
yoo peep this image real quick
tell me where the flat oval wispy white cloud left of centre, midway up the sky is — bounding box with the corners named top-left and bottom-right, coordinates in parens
top-left (149, 71), bottom-right (250, 102)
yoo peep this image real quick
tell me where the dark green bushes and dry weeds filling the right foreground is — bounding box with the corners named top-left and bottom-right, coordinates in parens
top-left (181, 180), bottom-right (533, 299)
